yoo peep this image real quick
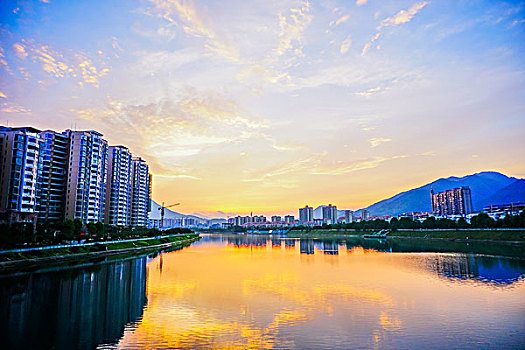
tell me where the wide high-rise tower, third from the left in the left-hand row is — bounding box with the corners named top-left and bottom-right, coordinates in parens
top-left (64, 130), bottom-right (108, 223)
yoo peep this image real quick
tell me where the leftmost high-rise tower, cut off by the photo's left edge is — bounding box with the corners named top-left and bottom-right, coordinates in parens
top-left (0, 127), bottom-right (41, 223)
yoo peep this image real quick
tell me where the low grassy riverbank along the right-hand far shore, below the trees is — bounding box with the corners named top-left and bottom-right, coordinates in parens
top-left (288, 229), bottom-right (525, 244)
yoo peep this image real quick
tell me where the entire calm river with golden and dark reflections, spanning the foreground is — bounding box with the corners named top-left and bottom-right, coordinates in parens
top-left (0, 235), bottom-right (525, 349)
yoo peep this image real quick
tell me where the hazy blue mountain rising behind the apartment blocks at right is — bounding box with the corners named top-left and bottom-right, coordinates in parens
top-left (364, 171), bottom-right (525, 215)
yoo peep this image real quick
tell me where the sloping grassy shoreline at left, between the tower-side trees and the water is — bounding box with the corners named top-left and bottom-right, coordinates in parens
top-left (0, 235), bottom-right (201, 278)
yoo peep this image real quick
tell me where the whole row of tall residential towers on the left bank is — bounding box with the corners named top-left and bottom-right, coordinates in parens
top-left (0, 126), bottom-right (152, 227)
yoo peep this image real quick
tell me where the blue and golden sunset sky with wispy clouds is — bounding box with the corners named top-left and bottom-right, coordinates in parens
top-left (0, 0), bottom-right (525, 217)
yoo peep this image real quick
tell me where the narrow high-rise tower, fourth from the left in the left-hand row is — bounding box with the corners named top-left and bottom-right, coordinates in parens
top-left (105, 146), bottom-right (132, 226)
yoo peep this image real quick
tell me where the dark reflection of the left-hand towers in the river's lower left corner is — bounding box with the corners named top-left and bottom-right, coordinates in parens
top-left (0, 257), bottom-right (147, 349)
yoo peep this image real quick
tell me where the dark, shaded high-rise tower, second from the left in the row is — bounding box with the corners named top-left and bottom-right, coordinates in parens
top-left (37, 130), bottom-right (69, 223)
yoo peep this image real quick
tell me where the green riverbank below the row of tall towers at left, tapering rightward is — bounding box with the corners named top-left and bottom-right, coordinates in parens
top-left (0, 234), bottom-right (200, 275)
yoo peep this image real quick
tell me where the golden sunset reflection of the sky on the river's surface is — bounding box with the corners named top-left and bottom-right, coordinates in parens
top-left (114, 239), bottom-right (525, 349)
